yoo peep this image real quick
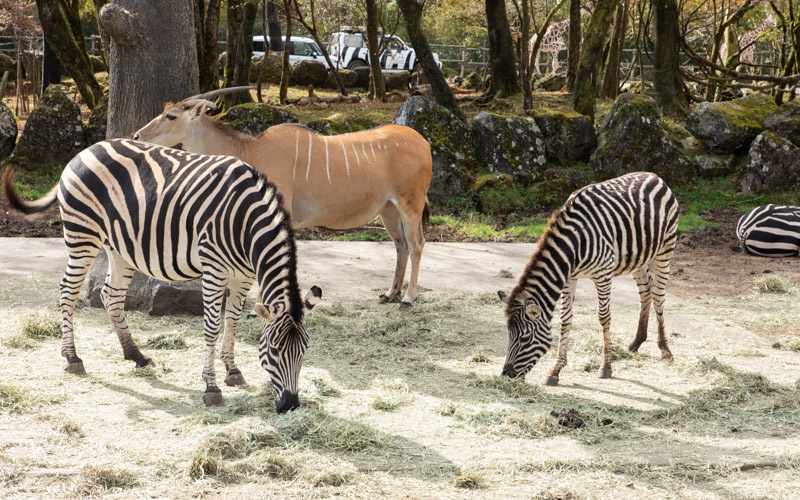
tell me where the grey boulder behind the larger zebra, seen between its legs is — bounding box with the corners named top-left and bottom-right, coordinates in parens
top-left (86, 252), bottom-right (203, 316)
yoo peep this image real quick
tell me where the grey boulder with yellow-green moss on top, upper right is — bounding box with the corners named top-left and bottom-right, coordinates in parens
top-left (686, 94), bottom-right (778, 154)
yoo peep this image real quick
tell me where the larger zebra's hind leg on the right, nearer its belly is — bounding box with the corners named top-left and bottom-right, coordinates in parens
top-left (100, 246), bottom-right (153, 368)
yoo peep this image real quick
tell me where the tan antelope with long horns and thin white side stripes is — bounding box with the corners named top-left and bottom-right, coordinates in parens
top-left (134, 88), bottom-right (433, 309)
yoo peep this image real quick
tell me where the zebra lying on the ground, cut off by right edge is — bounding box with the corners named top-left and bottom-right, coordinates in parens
top-left (736, 205), bottom-right (800, 257)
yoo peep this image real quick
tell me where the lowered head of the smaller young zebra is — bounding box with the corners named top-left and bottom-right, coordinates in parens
top-left (497, 292), bottom-right (553, 378)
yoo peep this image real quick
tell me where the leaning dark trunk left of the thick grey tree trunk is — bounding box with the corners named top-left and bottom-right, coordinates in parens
top-left (36, 0), bottom-right (103, 109)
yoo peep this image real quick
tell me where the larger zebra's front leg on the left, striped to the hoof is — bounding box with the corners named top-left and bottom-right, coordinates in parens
top-left (203, 268), bottom-right (228, 406)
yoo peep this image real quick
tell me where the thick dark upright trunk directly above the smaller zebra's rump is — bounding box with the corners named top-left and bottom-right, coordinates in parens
top-left (652, 0), bottom-right (689, 113)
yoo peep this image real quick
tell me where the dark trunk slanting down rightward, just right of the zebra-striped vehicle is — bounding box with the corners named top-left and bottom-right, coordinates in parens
top-left (397, 0), bottom-right (467, 121)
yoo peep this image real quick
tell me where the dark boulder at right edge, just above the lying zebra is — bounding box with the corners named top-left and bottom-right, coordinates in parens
top-left (739, 130), bottom-right (800, 194)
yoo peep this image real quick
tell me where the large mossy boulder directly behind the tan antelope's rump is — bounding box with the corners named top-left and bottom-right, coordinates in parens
top-left (392, 96), bottom-right (478, 202)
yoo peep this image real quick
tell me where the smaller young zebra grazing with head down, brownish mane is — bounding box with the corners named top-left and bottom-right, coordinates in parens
top-left (498, 172), bottom-right (678, 385)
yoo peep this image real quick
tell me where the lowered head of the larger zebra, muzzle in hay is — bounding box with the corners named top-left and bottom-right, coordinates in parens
top-left (253, 286), bottom-right (322, 413)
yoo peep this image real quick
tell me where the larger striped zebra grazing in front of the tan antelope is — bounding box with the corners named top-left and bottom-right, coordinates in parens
top-left (3, 139), bottom-right (321, 412)
